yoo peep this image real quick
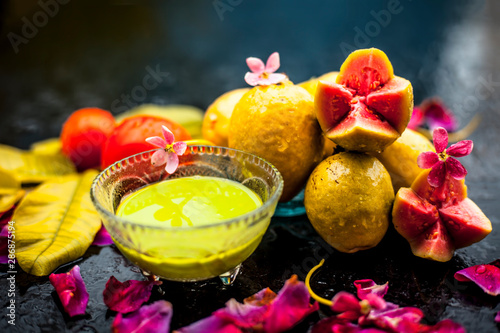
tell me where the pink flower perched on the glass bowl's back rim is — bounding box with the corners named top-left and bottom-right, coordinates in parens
top-left (146, 125), bottom-right (187, 174)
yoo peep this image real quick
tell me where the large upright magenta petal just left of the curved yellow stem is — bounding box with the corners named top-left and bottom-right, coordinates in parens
top-left (263, 275), bottom-right (319, 332)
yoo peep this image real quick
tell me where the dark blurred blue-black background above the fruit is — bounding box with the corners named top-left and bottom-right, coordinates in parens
top-left (0, 0), bottom-right (492, 148)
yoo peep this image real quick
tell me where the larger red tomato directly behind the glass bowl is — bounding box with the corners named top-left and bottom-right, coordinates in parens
top-left (101, 116), bottom-right (191, 169)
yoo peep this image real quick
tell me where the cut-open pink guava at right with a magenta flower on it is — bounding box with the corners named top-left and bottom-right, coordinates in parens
top-left (392, 170), bottom-right (491, 261)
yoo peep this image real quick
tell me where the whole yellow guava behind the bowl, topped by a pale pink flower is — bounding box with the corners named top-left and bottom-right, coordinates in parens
top-left (229, 82), bottom-right (324, 202)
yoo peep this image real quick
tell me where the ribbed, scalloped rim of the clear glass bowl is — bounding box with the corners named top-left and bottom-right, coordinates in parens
top-left (90, 145), bottom-right (284, 232)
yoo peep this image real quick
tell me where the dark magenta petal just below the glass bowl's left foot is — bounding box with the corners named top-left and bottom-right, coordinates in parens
top-left (102, 276), bottom-right (162, 313)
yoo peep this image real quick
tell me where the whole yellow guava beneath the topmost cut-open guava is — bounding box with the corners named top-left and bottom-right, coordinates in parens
top-left (304, 152), bottom-right (394, 253)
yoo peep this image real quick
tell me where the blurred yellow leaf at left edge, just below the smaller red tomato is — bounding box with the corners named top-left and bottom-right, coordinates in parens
top-left (0, 144), bottom-right (76, 183)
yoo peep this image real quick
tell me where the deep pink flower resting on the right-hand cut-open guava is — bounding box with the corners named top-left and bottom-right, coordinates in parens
top-left (417, 127), bottom-right (473, 187)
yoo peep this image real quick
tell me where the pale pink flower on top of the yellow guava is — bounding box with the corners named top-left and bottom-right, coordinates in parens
top-left (245, 52), bottom-right (287, 86)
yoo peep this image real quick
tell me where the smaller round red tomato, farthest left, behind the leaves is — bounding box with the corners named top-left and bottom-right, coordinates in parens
top-left (60, 108), bottom-right (115, 171)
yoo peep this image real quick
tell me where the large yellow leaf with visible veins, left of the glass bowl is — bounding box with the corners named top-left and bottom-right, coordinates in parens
top-left (12, 170), bottom-right (101, 276)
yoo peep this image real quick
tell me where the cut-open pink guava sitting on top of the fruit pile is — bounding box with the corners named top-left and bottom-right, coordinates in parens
top-left (315, 48), bottom-right (413, 151)
